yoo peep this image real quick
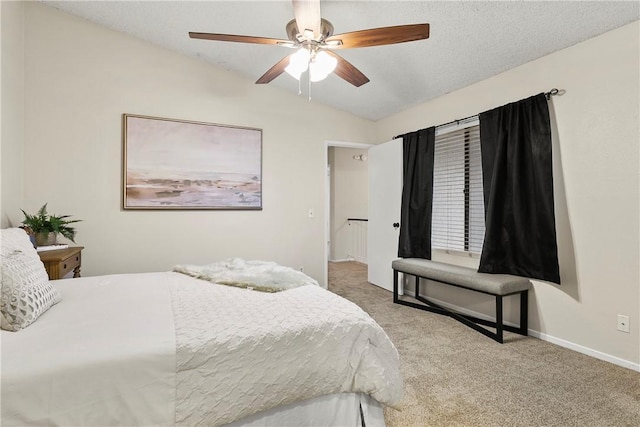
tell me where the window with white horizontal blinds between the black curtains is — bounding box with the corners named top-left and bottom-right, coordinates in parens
top-left (431, 118), bottom-right (484, 253)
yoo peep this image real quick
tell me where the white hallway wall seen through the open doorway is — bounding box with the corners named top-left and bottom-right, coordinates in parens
top-left (330, 147), bottom-right (369, 261)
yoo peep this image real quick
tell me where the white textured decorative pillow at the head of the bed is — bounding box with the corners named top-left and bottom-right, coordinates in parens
top-left (0, 228), bottom-right (61, 331)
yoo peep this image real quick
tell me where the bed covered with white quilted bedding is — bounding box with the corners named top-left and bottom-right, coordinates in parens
top-left (1, 229), bottom-right (402, 427)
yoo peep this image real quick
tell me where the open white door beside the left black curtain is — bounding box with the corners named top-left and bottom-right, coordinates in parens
top-left (367, 139), bottom-right (402, 291)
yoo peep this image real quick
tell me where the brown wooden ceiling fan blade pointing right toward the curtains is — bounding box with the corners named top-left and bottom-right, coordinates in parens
top-left (326, 24), bottom-right (429, 49)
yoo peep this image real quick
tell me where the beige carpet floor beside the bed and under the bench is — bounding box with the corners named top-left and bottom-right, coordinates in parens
top-left (329, 262), bottom-right (640, 427)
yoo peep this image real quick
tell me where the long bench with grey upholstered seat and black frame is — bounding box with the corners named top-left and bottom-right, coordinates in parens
top-left (391, 258), bottom-right (531, 343)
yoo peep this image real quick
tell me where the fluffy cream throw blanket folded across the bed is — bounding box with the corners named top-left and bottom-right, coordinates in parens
top-left (173, 258), bottom-right (319, 292)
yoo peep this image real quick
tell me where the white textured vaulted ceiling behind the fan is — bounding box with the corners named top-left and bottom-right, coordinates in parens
top-left (43, 1), bottom-right (640, 120)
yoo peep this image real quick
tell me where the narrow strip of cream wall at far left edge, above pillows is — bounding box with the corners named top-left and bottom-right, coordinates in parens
top-left (0, 1), bottom-right (24, 228)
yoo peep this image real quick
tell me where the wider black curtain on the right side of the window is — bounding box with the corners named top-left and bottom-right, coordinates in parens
top-left (478, 93), bottom-right (560, 284)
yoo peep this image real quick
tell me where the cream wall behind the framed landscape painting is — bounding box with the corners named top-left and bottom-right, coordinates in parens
top-left (13, 3), bottom-right (372, 281)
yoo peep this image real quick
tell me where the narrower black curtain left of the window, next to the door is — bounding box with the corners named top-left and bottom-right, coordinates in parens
top-left (398, 127), bottom-right (436, 259)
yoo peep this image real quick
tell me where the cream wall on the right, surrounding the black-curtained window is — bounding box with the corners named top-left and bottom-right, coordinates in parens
top-left (377, 22), bottom-right (640, 368)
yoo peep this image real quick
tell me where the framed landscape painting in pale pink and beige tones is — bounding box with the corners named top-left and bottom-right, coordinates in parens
top-left (123, 114), bottom-right (262, 209)
